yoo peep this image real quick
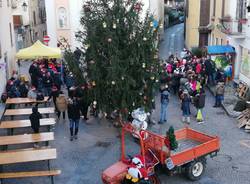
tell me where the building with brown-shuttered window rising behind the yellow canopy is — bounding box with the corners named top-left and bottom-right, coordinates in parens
top-left (11, 0), bottom-right (47, 51)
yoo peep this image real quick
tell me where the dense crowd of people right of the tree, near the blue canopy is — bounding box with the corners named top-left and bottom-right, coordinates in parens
top-left (159, 49), bottom-right (226, 124)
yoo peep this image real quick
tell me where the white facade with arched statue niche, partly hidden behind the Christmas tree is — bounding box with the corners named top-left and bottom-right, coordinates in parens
top-left (45, 0), bottom-right (164, 49)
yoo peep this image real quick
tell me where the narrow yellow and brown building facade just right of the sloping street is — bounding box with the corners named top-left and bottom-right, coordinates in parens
top-left (185, 0), bottom-right (212, 49)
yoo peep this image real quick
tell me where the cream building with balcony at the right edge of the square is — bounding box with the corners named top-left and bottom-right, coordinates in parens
top-left (209, 0), bottom-right (250, 82)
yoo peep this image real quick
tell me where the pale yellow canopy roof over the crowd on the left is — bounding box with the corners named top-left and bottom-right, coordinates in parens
top-left (16, 40), bottom-right (62, 59)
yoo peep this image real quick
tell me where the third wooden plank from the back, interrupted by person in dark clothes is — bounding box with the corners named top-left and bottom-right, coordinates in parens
top-left (0, 118), bottom-right (56, 129)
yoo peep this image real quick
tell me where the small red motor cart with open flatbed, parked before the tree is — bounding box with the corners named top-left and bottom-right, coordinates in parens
top-left (102, 124), bottom-right (220, 184)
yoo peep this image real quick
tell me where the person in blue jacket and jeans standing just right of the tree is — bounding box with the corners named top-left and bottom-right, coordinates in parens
top-left (159, 84), bottom-right (169, 124)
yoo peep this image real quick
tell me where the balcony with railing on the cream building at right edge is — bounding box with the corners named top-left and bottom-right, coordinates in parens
top-left (217, 19), bottom-right (247, 37)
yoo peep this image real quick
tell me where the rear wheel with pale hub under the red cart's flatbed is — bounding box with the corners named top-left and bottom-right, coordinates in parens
top-left (186, 159), bottom-right (206, 181)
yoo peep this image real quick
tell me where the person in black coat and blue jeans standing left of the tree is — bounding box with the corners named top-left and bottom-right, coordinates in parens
top-left (68, 97), bottom-right (80, 141)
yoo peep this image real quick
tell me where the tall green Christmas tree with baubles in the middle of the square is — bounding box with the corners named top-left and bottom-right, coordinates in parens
top-left (66, 0), bottom-right (161, 117)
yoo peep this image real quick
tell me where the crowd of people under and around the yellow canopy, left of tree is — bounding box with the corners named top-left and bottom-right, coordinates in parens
top-left (2, 59), bottom-right (94, 141)
